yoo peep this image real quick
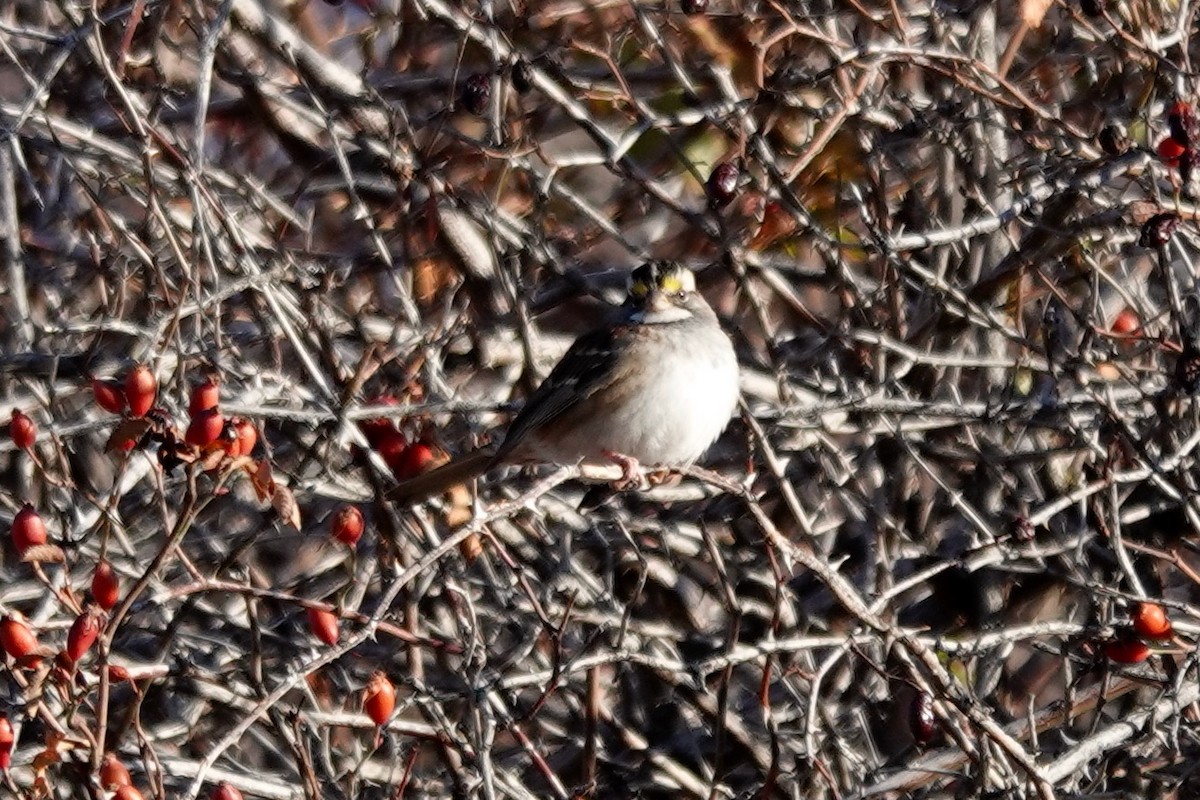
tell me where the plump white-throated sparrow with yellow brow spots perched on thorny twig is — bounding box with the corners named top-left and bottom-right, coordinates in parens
top-left (389, 261), bottom-right (738, 500)
